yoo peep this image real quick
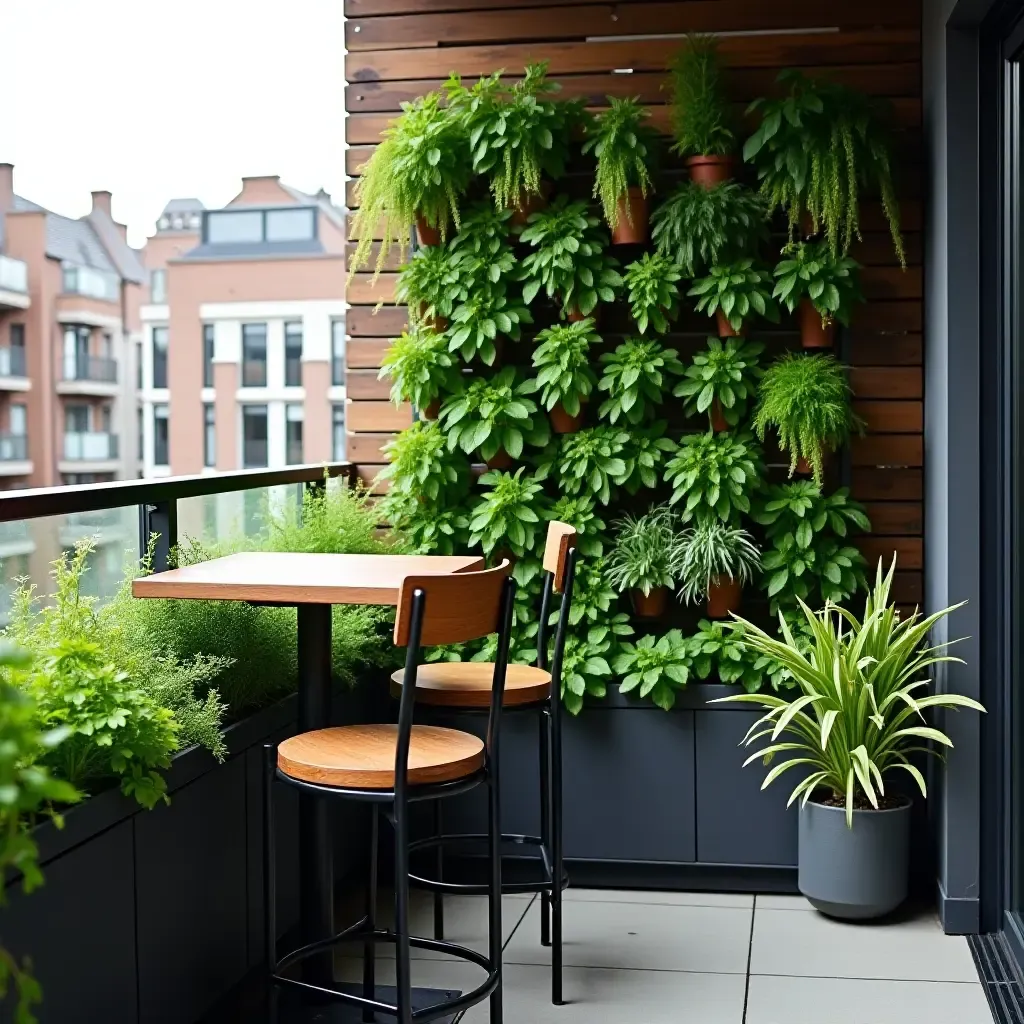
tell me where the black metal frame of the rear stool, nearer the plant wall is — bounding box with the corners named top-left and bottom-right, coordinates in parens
top-left (401, 547), bottom-right (578, 1006)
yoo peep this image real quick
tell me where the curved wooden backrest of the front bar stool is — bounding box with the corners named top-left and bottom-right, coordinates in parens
top-left (394, 558), bottom-right (512, 647)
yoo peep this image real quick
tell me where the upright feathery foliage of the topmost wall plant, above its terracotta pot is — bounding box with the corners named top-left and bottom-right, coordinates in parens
top-left (669, 34), bottom-right (735, 157)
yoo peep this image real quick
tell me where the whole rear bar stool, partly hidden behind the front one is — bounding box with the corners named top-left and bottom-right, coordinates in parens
top-left (391, 522), bottom-right (577, 1006)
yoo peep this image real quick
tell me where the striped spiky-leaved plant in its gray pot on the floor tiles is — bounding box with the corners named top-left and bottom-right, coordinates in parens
top-left (720, 558), bottom-right (985, 920)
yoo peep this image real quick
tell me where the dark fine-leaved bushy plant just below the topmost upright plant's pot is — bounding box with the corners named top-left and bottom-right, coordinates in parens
top-left (650, 181), bottom-right (768, 278)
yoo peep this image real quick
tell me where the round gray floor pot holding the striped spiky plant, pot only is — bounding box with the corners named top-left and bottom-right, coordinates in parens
top-left (798, 800), bottom-right (910, 921)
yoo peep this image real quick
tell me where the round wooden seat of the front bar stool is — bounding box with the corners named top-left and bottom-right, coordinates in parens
top-left (278, 725), bottom-right (483, 790)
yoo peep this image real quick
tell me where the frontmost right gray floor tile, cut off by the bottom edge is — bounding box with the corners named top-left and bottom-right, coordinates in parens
top-left (745, 977), bottom-right (992, 1024)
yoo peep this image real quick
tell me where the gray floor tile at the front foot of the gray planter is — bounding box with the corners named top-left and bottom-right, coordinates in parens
top-left (751, 907), bottom-right (978, 982)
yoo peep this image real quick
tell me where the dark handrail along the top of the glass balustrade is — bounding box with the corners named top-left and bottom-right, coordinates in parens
top-left (0, 462), bottom-right (355, 522)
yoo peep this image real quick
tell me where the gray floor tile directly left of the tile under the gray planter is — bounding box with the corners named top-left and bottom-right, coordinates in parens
top-left (505, 900), bottom-right (753, 974)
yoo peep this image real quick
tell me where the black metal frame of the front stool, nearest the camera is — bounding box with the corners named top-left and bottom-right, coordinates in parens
top-left (263, 575), bottom-right (516, 1024)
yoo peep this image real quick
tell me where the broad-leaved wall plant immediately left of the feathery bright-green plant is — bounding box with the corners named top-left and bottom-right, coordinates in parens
top-left (673, 338), bottom-right (764, 427)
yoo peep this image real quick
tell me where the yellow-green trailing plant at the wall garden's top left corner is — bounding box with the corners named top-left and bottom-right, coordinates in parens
top-left (349, 91), bottom-right (471, 276)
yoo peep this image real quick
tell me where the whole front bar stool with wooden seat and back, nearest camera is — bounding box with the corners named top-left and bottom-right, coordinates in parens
top-left (264, 560), bottom-right (515, 1024)
